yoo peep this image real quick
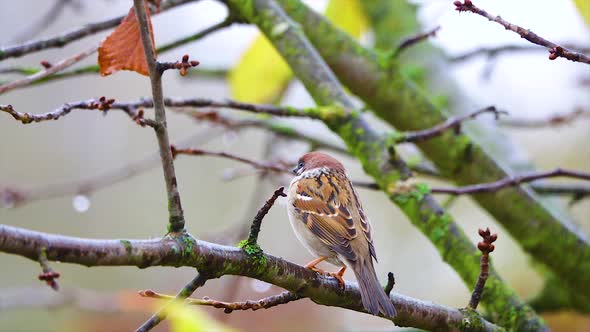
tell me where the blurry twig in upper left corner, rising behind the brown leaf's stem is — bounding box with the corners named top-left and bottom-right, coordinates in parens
top-left (0, 0), bottom-right (195, 61)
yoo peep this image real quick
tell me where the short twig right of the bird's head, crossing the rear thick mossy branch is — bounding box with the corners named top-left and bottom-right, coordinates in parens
top-left (396, 106), bottom-right (508, 143)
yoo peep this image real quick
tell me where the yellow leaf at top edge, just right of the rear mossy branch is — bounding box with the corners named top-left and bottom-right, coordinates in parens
top-left (326, 0), bottom-right (369, 39)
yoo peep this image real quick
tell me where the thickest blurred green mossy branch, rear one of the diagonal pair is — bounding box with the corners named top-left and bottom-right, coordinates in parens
top-left (278, 0), bottom-right (590, 308)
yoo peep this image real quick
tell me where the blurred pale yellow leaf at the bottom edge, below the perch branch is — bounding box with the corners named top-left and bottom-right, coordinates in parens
top-left (166, 302), bottom-right (235, 332)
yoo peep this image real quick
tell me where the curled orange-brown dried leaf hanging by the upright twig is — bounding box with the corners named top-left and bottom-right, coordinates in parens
top-left (98, 6), bottom-right (155, 76)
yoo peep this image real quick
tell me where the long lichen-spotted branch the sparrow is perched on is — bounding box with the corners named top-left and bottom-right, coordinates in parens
top-left (0, 225), bottom-right (500, 331)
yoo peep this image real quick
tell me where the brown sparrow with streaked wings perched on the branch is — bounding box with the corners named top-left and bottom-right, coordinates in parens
top-left (287, 152), bottom-right (396, 317)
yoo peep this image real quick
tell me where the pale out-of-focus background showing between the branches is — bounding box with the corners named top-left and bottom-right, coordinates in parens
top-left (0, 0), bottom-right (590, 331)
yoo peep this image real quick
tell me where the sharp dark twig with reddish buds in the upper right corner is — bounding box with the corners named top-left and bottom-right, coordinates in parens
top-left (454, 0), bottom-right (590, 64)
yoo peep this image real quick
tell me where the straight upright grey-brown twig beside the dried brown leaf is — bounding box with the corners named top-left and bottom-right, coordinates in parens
top-left (133, 0), bottom-right (184, 233)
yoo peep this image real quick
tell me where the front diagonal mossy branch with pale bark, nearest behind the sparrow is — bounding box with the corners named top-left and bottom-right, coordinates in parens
top-left (227, 0), bottom-right (545, 331)
